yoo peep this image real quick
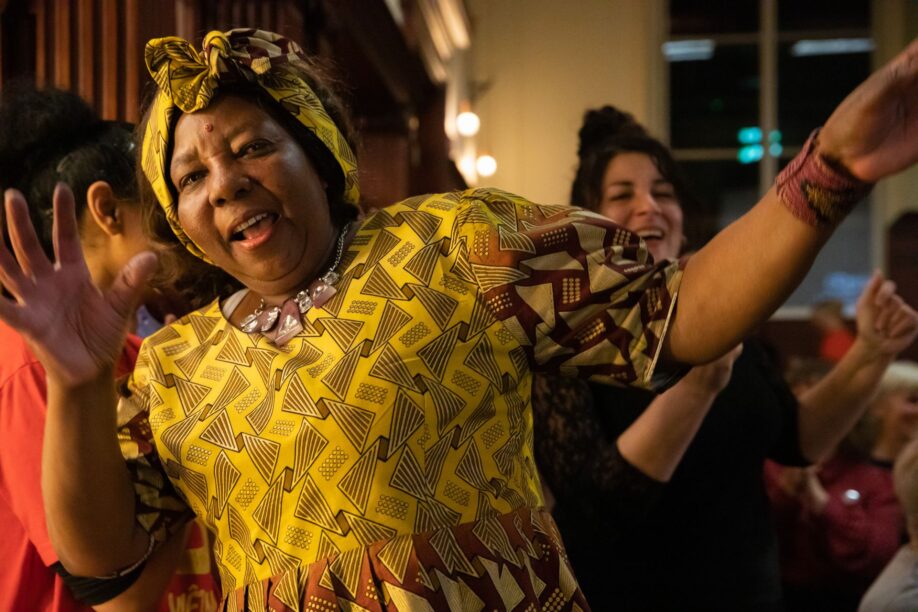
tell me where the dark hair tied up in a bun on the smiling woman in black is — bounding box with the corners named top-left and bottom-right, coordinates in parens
top-left (570, 106), bottom-right (695, 216)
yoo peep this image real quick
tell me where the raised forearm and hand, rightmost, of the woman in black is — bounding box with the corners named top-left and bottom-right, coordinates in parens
top-left (799, 273), bottom-right (918, 462)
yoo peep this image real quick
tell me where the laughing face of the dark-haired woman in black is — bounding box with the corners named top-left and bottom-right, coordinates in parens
top-left (599, 153), bottom-right (683, 260)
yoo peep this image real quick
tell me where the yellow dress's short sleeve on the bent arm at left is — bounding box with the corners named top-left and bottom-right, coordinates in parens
top-left (118, 347), bottom-right (194, 543)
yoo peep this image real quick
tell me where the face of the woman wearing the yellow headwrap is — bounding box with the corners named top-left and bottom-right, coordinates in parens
top-left (169, 96), bottom-right (336, 298)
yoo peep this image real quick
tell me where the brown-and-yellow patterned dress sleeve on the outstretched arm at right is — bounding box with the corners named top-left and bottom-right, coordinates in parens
top-left (455, 189), bottom-right (682, 389)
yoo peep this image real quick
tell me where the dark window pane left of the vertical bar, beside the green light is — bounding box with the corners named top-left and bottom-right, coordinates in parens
top-left (669, 45), bottom-right (759, 148)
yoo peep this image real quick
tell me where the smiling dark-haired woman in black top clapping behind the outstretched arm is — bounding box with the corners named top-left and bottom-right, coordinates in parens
top-left (533, 106), bottom-right (918, 611)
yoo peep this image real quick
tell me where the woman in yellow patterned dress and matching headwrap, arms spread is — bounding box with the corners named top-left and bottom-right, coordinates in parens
top-left (0, 30), bottom-right (918, 610)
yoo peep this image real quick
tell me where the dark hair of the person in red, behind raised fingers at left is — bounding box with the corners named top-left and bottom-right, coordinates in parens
top-left (0, 82), bottom-right (139, 257)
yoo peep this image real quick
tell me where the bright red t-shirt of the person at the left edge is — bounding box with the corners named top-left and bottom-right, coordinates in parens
top-left (0, 322), bottom-right (220, 612)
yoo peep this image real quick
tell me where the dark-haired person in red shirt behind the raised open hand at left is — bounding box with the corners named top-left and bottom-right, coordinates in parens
top-left (0, 86), bottom-right (220, 612)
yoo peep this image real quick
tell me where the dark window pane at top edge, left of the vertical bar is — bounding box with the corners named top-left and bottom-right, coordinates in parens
top-left (669, 0), bottom-right (759, 35)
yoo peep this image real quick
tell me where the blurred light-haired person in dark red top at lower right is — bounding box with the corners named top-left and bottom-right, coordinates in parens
top-left (766, 361), bottom-right (918, 612)
